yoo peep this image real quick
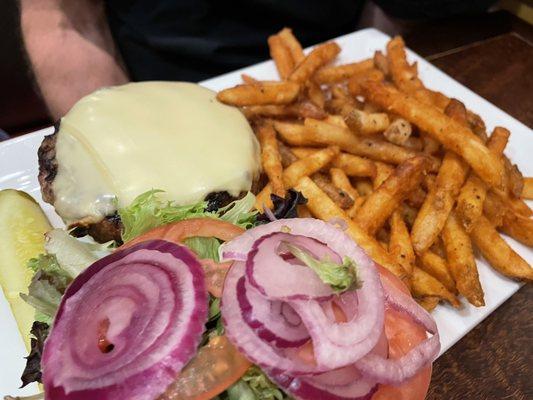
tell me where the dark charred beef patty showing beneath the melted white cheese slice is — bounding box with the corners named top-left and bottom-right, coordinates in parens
top-left (37, 129), bottom-right (258, 243)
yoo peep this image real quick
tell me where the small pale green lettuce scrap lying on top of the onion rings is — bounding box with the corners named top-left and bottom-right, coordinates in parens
top-left (284, 243), bottom-right (361, 293)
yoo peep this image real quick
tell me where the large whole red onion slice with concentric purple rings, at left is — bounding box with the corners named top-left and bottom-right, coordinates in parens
top-left (42, 240), bottom-right (207, 400)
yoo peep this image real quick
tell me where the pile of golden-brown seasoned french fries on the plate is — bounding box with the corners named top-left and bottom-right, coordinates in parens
top-left (218, 28), bottom-right (533, 310)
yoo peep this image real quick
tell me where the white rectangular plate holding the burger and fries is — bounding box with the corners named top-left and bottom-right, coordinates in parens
top-left (0, 29), bottom-right (533, 395)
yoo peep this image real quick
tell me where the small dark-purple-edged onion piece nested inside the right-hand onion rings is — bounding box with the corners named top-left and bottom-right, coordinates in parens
top-left (237, 280), bottom-right (309, 348)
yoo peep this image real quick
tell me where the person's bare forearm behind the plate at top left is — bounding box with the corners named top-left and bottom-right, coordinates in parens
top-left (20, 0), bottom-right (128, 119)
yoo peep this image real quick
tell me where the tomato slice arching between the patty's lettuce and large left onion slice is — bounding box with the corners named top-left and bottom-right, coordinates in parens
top-left (121, 218), bottom-right (244, 297)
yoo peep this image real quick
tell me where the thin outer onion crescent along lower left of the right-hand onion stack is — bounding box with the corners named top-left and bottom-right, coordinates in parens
top-left (220, 262), bottom-right (325, 375)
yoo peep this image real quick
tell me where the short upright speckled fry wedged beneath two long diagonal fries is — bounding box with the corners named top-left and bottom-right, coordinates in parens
top-left (389, 209), bottom-right (416, 276)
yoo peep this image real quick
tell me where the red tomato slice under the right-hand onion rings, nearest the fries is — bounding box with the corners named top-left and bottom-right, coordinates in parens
top-left (372, 266), bottom-right (431, 400)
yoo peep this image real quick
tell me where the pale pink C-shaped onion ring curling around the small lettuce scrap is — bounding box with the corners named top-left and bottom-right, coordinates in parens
top-left (246, 232), bottom-right (341, 301)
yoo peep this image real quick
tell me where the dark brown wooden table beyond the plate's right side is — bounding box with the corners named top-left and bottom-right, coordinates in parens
top-left (374, 9), bottom-right (533, 400)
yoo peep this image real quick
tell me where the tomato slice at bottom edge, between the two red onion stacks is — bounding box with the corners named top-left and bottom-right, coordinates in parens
top-left (159, 336), bottom-right (252, 400)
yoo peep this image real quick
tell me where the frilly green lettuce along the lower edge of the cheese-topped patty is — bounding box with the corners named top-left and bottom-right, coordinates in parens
top-left (118, 189), bottom-right (257, 242)
